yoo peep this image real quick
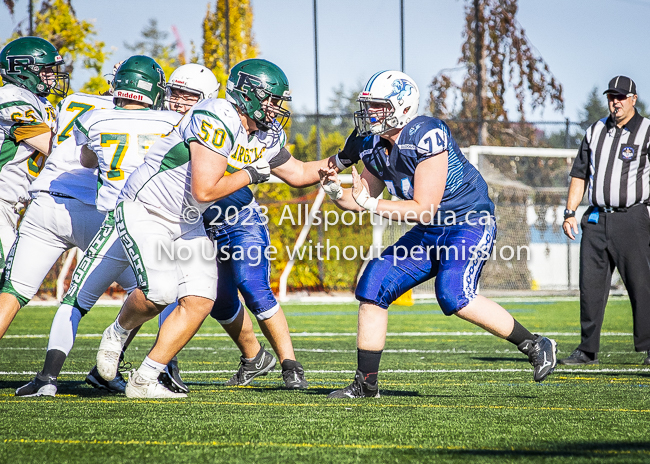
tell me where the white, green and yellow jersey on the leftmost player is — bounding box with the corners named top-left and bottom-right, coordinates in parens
top-left (0, 84), bottom-right (56, 204)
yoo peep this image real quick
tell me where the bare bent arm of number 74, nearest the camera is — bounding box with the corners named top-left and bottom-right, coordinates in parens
top-left (368, 151), bottom-right (448, 223)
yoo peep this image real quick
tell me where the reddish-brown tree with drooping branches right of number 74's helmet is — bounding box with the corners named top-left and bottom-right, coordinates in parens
top-left (429, 0), bottom-right (563, 146)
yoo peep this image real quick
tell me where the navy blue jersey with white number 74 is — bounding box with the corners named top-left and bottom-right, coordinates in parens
top-left (343, 116), bottom-right (494, 225)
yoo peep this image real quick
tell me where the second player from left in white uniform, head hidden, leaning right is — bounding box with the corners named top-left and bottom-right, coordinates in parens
top-left (7, 93), bottom-right (139, 394)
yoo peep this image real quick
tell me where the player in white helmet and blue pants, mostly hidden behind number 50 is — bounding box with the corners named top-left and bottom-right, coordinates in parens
top-left (159, 62), bottom-right (308, 393)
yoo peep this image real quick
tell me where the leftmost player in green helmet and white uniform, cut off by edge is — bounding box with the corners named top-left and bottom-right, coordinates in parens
top-left (0, 37), bottom-right (68, 278)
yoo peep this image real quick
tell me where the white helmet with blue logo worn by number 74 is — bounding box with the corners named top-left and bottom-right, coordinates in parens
top-left (354, 71), bottom-right (420, 136)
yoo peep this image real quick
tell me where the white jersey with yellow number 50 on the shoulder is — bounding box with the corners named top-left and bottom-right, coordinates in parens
top-left (118, 99), bottom-right (286, 224)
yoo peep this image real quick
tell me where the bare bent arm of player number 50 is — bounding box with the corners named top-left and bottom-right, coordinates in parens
top-left (190, 141), bottom-right (250, 203)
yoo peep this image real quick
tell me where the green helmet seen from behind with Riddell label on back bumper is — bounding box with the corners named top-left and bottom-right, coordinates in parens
top-left (113, 55), bottom-right (165, 110)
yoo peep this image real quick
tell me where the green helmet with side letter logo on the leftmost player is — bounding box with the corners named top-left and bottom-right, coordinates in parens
top-left (0, 37), bottom-right (70, 97)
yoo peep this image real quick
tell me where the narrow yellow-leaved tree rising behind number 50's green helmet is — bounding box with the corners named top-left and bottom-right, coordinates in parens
top-left (202, 0), bottom-right (257, 97)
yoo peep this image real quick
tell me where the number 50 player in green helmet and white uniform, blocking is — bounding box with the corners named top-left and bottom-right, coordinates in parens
top-left (97, 59), bottom-right (344, 398)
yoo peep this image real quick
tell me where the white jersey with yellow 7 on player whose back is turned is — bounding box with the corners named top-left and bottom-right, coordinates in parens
top-left (72, 108), bottom-right (182, 212)
